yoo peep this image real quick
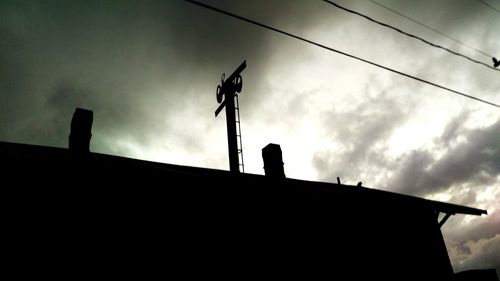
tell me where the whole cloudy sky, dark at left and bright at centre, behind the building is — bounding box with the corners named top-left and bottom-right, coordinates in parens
top-left (0, 0), bottom-right (500, 274)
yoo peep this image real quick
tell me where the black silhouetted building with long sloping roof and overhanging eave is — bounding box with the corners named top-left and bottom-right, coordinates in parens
top-left (0, 110), bottom-right (494, 280)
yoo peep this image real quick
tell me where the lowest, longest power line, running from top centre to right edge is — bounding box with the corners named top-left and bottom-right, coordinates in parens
top-left (185, 0), bottom-right (500, 108)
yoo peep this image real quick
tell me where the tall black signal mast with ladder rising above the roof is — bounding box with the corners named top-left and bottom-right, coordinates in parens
top-left (215, 60), bottom-right (247, 173)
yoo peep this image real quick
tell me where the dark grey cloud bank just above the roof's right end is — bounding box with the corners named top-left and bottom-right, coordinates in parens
top-left (388, 116), bottom-right (500, 195)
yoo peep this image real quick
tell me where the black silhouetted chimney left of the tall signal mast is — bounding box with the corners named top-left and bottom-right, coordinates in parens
top-left (69, 108), bottom-right (94, 153)
